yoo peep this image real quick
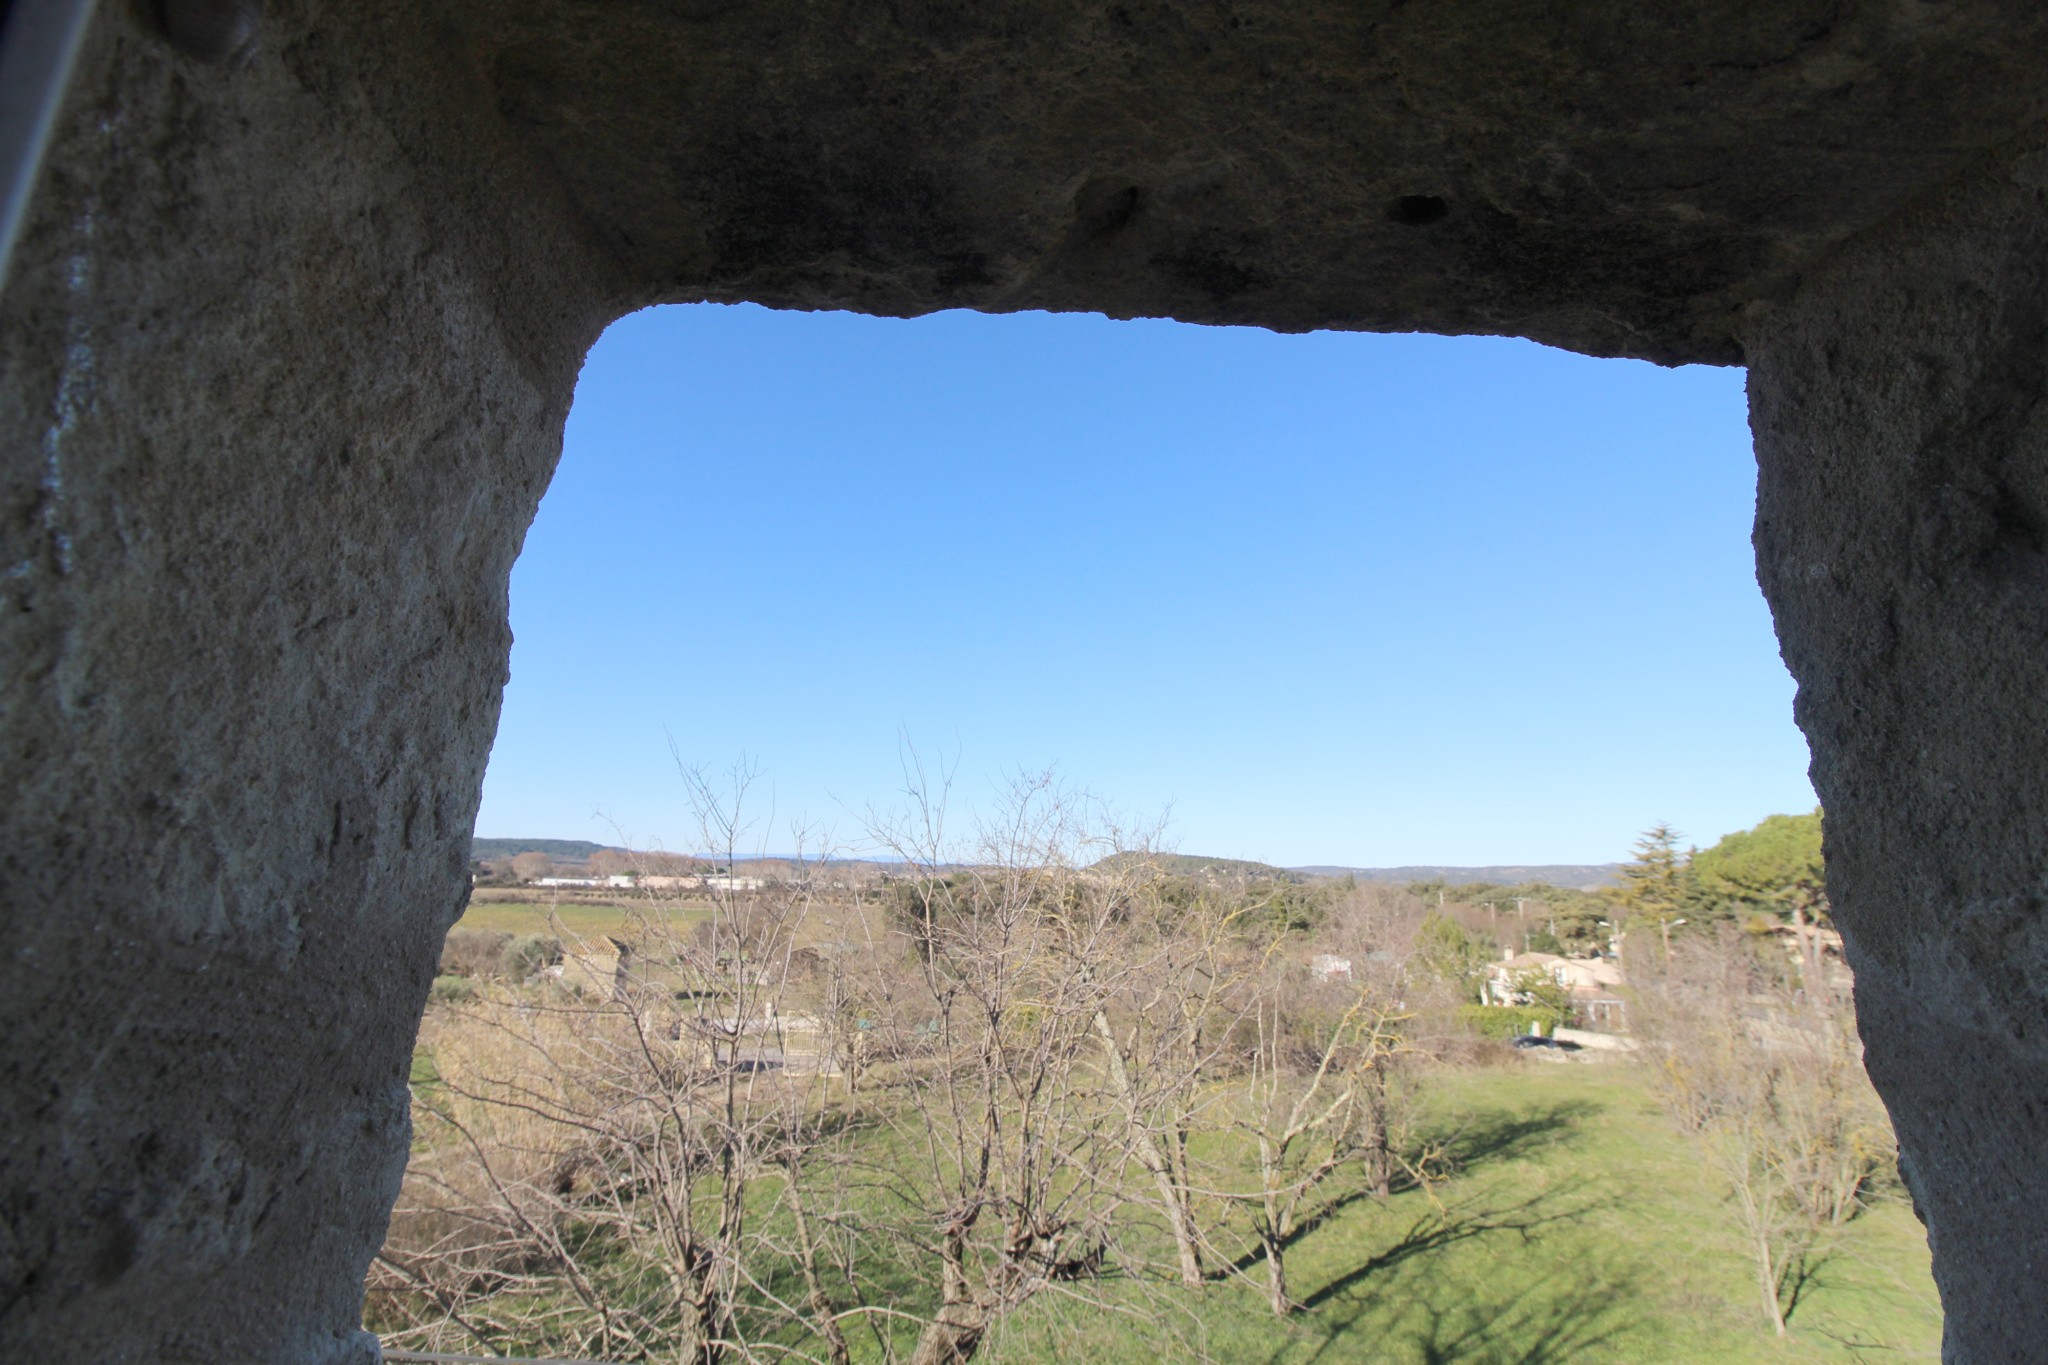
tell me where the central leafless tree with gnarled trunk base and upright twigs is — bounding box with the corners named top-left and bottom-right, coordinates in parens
top-left (874, 778), bottom-right (1155, 1365)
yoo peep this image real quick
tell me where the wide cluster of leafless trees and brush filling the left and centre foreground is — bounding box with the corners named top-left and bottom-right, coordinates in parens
top-left (369, 774), bottom-right (1456, 1365)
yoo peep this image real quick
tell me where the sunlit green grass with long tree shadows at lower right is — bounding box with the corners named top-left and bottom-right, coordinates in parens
top-left (989, 1062), bottom-right (1942, 1365)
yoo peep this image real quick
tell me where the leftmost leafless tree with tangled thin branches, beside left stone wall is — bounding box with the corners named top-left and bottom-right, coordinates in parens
top-left (373, 765), bottom-right (848, 1365)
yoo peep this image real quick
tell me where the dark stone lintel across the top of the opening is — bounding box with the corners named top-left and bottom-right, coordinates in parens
top-left (468, 0), bottom-right (2048, 362)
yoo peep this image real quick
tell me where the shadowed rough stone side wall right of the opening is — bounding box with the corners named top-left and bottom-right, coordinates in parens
top-left (1749, 136), bottom-right (2048, 1365)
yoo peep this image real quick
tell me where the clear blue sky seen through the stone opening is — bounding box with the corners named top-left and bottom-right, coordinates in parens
top-left (477, 307), bottom-right (1812, 866)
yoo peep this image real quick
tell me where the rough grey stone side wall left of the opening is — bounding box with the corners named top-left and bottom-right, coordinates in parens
top-left (0, 0), bottom-right (616, 1365)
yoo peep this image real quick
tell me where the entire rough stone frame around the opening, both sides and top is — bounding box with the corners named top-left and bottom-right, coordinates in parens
top-left (12, 0), bottom-right (2048, 1365)
